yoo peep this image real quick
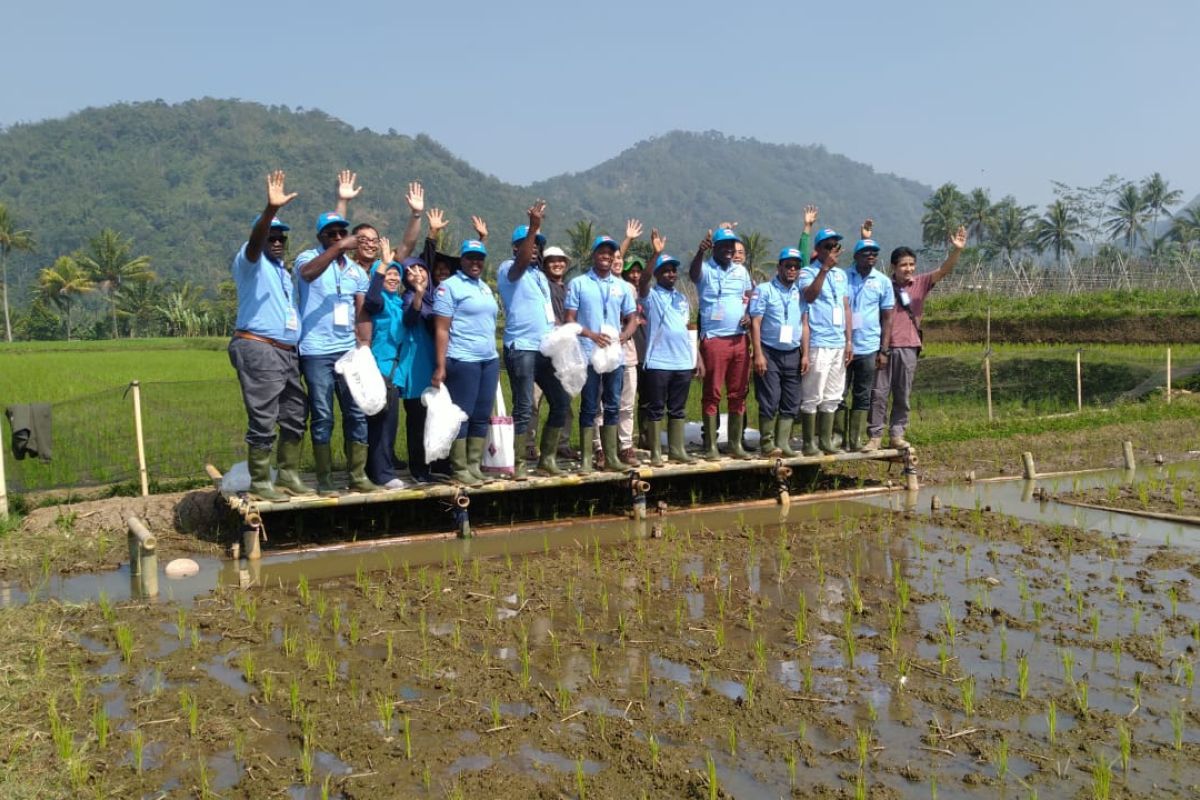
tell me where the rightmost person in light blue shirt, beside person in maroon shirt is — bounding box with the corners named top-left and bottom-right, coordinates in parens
top-left (845, 226), bottom-right (895, 452)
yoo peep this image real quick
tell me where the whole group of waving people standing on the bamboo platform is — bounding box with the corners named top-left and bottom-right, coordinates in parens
top-left (229, 172), bottom-right (966, 500)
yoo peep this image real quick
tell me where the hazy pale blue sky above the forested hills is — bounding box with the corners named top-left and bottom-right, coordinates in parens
top-left (0, 0), bottom-right (1200, 206)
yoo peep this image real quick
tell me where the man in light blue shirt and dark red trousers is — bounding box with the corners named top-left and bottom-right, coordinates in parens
top-left (688, 228), bottom-right (754, 461)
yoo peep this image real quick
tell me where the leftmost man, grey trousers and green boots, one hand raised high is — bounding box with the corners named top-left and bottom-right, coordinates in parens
top-left (229, 170), bottom-right (312, 500)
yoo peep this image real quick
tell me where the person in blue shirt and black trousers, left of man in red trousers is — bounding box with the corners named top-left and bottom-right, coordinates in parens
top-left (638, 230), bottom-right (696, 467)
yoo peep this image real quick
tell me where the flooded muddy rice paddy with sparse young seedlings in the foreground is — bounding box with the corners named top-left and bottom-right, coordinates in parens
top-left (2, 463), bottom-right (1200, 798)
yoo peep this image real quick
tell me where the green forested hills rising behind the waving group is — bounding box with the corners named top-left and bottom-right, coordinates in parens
top-left (0, 98), bottom-right (930, 298)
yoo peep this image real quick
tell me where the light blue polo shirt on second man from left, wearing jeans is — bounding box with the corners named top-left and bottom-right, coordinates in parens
top-left (295, 247), bottom-right (371, 355)
